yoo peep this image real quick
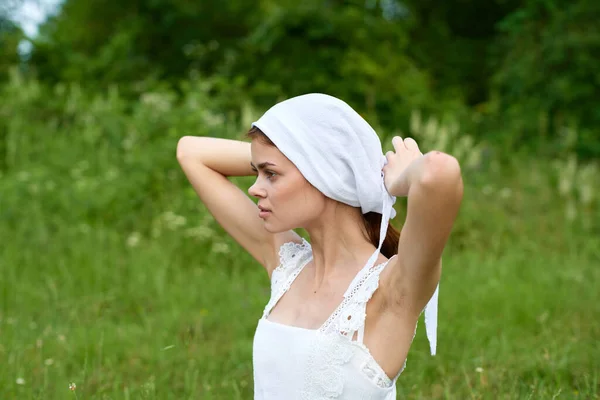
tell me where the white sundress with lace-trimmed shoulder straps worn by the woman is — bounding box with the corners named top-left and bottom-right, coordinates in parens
top-left (253, 239), bottom-right (406, 400)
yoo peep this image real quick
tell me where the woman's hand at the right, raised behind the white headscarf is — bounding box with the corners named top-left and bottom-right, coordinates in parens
top-left (382, 136), bottom-right (423, 197)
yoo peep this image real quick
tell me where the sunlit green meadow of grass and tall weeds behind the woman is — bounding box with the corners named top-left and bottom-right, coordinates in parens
top-left (0, 76), bottom-right (600, 399)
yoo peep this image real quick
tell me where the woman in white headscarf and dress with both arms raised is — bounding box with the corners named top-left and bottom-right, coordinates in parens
top-left (177, 94), bottom-right (463, 400)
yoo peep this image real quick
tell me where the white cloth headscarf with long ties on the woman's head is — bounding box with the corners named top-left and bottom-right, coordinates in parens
top-left (252, 93), bottom-right (439, 355)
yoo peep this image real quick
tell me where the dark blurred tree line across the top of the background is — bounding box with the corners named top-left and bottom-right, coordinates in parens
top-left (0, 0), bottom-right (600, 158)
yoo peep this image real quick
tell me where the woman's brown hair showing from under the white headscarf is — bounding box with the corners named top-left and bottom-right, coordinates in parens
top-left (246, 126), bottom-right (400, 258)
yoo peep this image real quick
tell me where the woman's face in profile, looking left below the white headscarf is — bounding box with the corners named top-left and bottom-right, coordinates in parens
top-left (248, 139), bottom-right (327, 233)
